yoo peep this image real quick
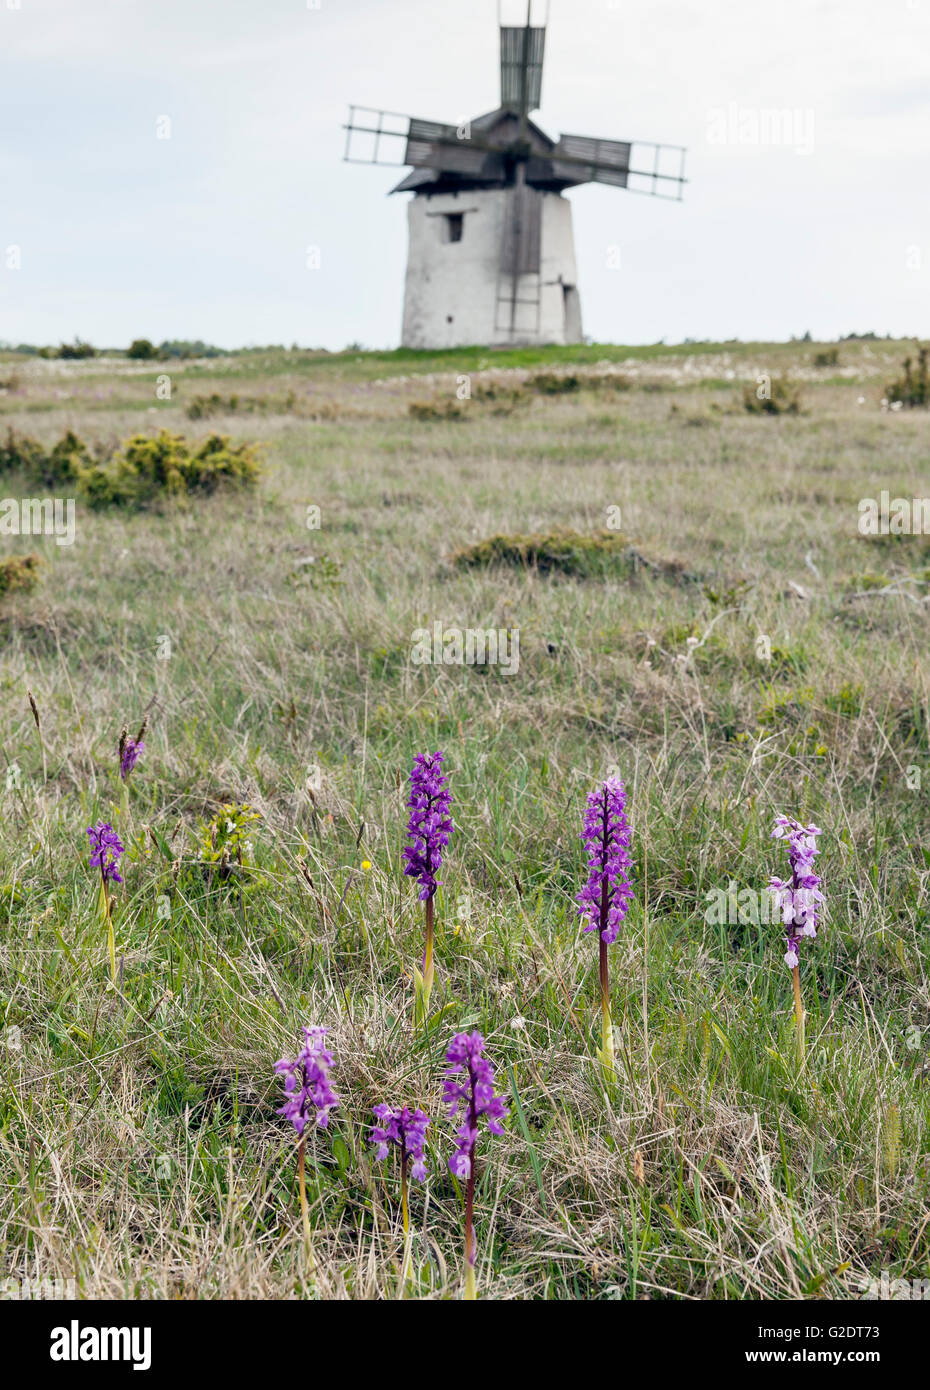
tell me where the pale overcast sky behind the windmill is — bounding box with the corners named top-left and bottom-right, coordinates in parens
top-left (0, 0), bottom-right (930, 348)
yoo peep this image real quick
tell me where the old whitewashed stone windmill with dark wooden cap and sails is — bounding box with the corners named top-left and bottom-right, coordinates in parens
top-left (343, 0), bottom-right (685, 348)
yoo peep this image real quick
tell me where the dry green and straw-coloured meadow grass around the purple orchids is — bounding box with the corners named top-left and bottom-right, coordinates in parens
top-left (0, 343), bottom-right (930, 1298)
